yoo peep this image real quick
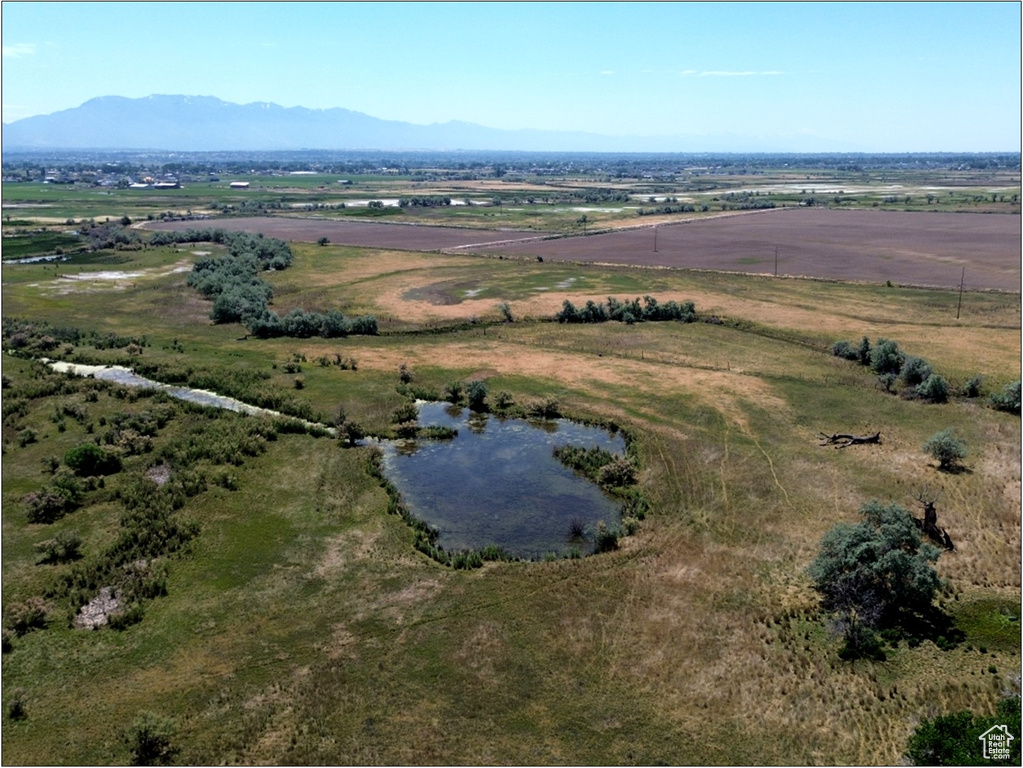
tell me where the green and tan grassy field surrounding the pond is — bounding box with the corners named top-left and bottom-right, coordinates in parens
top-left (2, 191), bottom-right (1021, 765)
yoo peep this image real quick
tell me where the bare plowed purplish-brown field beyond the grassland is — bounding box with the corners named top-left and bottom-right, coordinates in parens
top-left (149, 209), bottom-right (1021, 291)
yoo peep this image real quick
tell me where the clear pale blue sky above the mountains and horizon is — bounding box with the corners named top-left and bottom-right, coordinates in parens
top-left (2, 2), bottom-right (1021, 151)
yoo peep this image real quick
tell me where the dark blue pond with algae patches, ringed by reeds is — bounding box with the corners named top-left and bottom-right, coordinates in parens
top-left (381, 403), bottom-right (625, 559)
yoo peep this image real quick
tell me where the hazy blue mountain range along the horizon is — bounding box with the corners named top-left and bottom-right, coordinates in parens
top-left (3, 96), bottom-right (844, 151)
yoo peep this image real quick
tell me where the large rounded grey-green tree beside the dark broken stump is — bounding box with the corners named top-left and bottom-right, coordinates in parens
top-left (807, 501), bottom-right (941, 648)
